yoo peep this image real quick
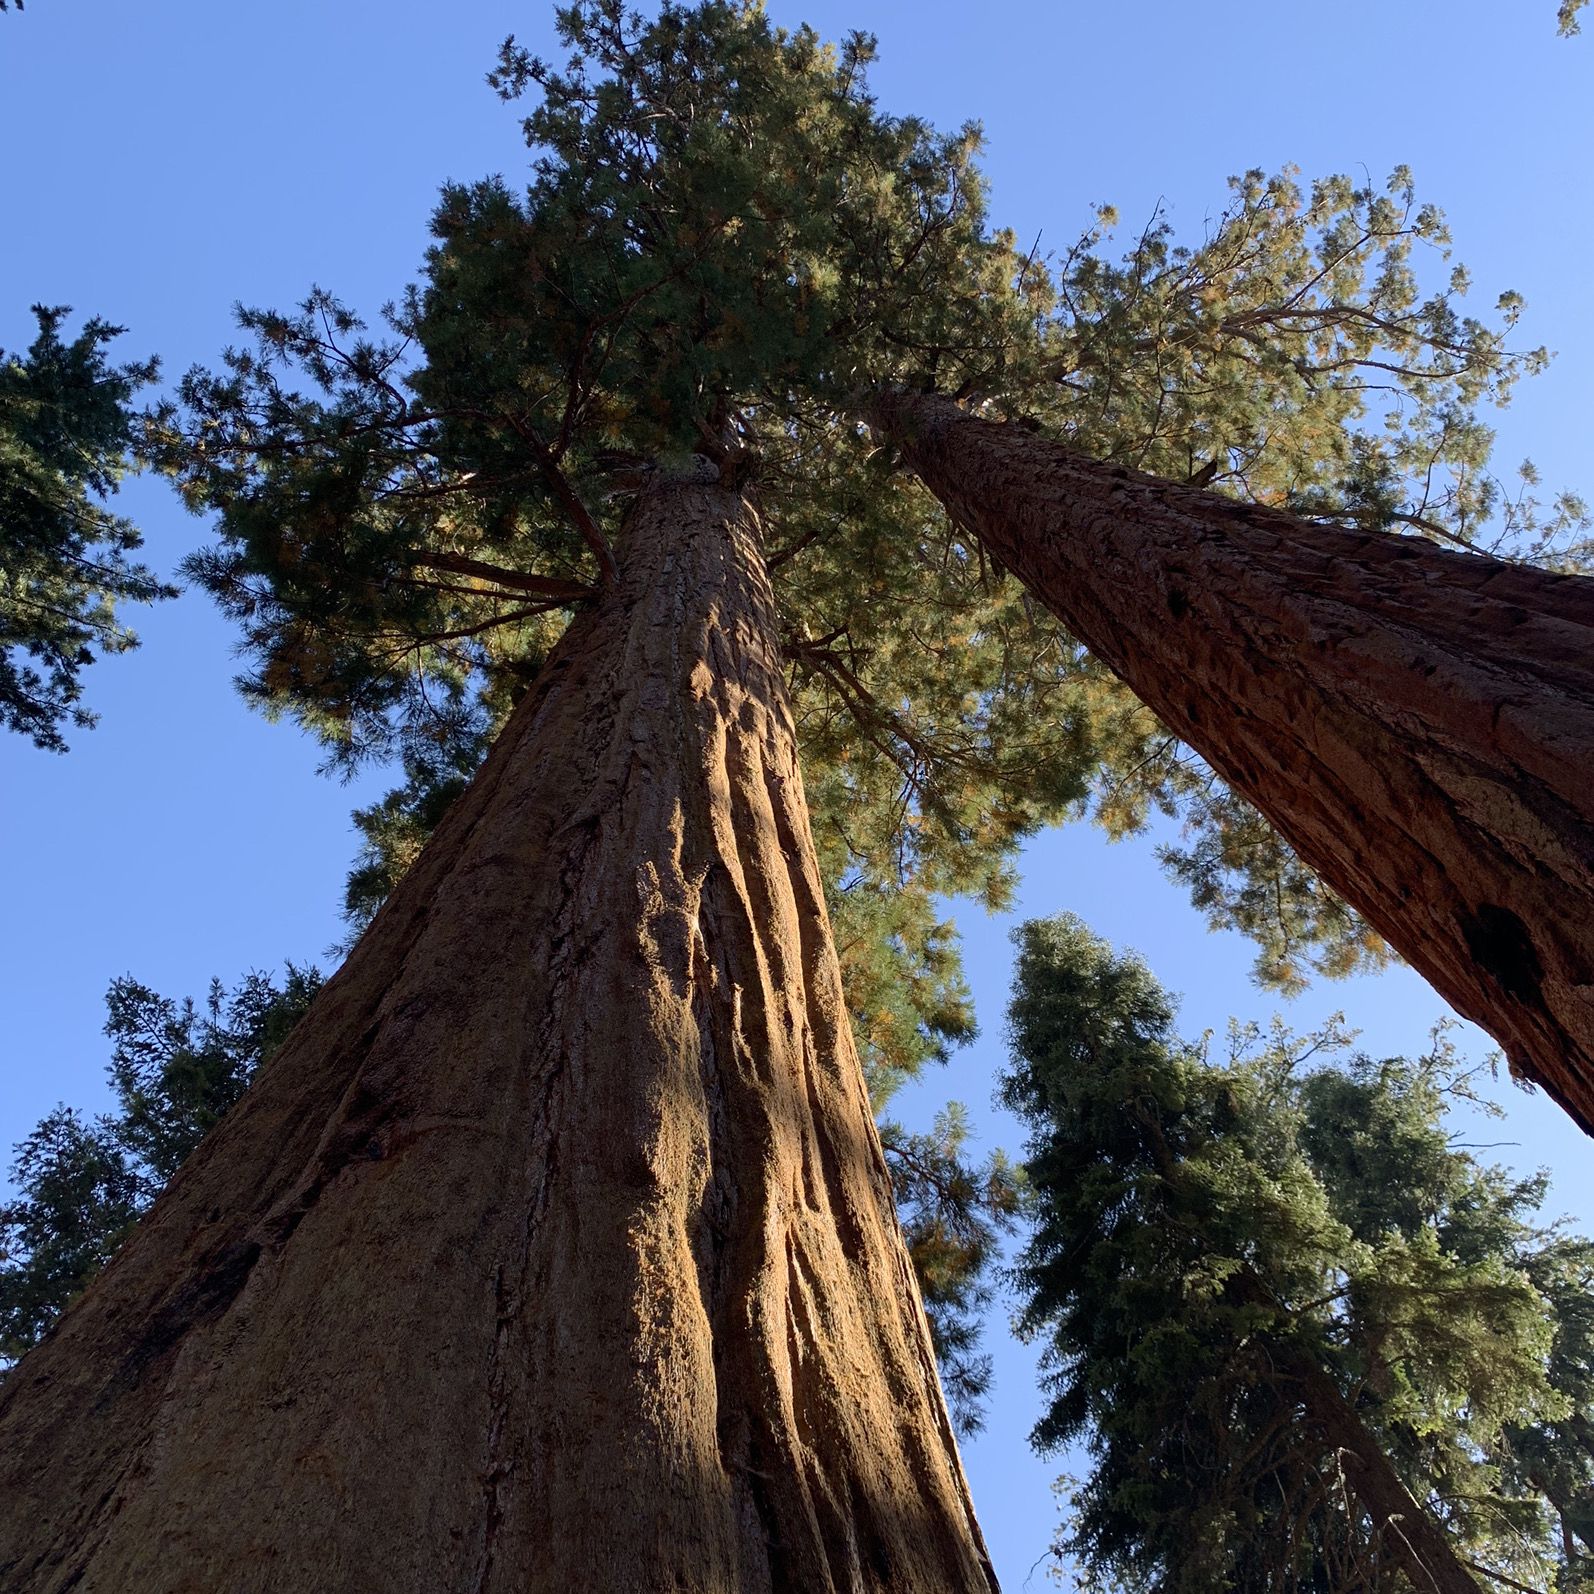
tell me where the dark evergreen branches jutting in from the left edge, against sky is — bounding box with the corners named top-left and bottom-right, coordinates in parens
top-left (0, 312), bottom-right (175, 751)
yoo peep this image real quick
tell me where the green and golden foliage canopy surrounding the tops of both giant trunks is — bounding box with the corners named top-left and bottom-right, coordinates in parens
top-left (156, 0), bottom-right (1578, 1039)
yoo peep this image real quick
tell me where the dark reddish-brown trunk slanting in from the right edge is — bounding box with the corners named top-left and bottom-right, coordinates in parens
top-left (872, 394), bottom-right (1594, 1133)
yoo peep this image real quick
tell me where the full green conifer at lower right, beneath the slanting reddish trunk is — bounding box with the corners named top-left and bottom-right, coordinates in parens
top-left (1004, 918), bottom-right (1594, 1594)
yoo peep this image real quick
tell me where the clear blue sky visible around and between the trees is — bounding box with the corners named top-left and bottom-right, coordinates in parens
top-left (0, 0), bottom-right (1594, 1591)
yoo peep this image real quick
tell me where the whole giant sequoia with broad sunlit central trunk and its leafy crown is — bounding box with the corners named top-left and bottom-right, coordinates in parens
top-left (0, 0), bottom-right (1568, 1594)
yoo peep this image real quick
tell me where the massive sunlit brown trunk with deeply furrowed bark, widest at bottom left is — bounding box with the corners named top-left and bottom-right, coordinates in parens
top-left (0, 471), bottom-right (995, 1594)
